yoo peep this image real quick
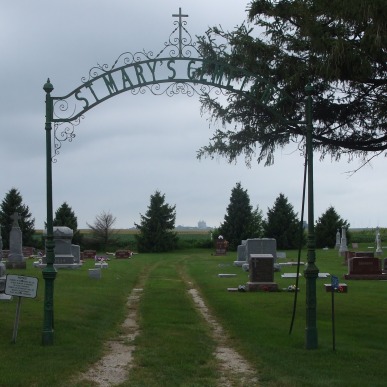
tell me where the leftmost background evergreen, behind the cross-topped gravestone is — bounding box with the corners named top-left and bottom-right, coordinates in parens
top-left (0, 188), bottom-right (35, 249)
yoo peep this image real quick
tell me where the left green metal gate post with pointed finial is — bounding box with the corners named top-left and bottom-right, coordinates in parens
top-left (42, 79), bottom-right (56, 345)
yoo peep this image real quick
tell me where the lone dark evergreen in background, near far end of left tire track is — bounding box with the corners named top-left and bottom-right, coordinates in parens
top-left (135, 191), bottom-right (178, 253)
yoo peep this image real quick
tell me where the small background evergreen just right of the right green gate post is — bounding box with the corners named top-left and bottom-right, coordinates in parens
top-left (315, 206), bottom-right (350, 248)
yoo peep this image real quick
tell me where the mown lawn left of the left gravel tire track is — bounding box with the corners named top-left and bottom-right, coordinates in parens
top-left (0, 260), bottom-right (144, 387)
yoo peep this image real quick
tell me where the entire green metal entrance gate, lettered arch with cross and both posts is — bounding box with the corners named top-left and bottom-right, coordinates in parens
top-left (42, 8), bottom-right (318, 348)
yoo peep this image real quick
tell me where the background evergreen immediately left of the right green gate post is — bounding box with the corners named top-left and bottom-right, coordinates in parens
top-left (264, 193), bottom-right (300, 249)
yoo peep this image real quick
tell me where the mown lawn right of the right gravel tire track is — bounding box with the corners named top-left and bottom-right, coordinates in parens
top-left (186, 247), bottom-right (387, 387)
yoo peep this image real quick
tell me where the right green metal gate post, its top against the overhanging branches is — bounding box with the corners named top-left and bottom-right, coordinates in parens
top-left (304, 85), bottom-right (319, 349)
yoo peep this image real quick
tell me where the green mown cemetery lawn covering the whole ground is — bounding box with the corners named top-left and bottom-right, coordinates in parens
top-left (0, 244), bottom-right (387, 387)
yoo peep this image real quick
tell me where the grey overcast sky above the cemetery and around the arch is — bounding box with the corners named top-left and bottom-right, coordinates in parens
top-left (0, 0), bottom-right (387, 229)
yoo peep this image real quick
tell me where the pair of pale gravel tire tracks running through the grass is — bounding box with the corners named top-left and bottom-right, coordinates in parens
top-left (76, 271), bottom-right (258, 387)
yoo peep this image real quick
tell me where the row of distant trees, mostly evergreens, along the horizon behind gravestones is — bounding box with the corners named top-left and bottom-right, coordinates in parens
top-left (0, 186), bottom-right (350, 253)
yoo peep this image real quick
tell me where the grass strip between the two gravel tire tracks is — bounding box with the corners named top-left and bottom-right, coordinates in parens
top-left (126, 254), bottom-right (218, 387)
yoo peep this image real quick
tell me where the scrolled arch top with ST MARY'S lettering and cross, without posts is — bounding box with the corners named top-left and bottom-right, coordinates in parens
top-left (45, 8), bottom-right (290, 156)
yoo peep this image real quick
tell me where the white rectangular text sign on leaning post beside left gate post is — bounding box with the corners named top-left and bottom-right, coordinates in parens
top-left (4, 274), bottom-right (38, 343)
